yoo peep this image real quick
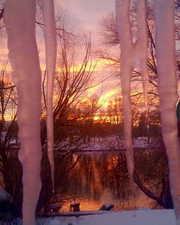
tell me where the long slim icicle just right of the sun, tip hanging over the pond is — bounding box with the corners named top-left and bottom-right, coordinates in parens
top-left (116, 0), bottom-right (134, 179)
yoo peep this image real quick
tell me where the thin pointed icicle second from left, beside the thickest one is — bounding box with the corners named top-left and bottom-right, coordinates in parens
top-left (41, 0), bottom-right (57, 192)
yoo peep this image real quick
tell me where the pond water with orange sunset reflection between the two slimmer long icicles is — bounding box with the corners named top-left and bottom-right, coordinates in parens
top-left (56, 153), bottom-right (158, 211)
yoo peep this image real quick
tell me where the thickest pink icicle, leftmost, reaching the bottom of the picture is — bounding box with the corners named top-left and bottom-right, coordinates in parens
top-left (5, 0), bottom-right (41, 225)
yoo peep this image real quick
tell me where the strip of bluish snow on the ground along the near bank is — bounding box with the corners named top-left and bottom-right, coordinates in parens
top-left (38, 209), bottom-right (175, 225)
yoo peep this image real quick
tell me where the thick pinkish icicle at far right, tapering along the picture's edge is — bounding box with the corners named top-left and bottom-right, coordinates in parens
top-left (155, 0), bottom-right (180, 225)
